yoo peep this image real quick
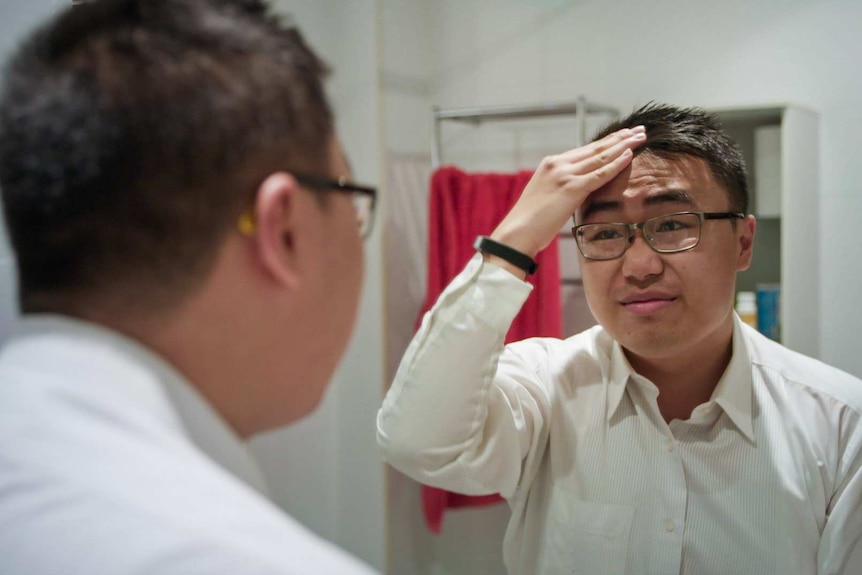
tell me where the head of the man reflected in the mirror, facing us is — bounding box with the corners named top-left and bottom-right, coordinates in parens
top-left (575, 105), bottom-right (755, 374)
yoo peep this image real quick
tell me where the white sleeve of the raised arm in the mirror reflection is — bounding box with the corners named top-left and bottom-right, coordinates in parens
top-left (377, 254), bottom-right (549, 498)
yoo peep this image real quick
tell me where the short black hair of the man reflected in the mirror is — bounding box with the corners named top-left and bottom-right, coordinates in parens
top-left (594, 102), bottom-right (749, 213)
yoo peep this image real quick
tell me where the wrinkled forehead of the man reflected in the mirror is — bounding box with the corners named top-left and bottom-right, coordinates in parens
top-left (577, 153), bottom-right (729, 220)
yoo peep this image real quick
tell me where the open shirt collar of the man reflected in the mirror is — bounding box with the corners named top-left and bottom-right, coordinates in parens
top-left (607, 318), bottom-right (754, 442)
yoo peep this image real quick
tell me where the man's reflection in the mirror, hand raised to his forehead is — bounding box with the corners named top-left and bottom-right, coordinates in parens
top-left (378, 105), bottom-right (862, 575)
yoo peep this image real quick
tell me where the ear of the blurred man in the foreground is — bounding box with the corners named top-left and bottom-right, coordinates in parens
top-left (254, 172), bottom-right (302, 288)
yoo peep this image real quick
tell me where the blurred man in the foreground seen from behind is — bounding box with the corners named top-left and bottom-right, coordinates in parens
top-left (0, 0), bottom-right (374, 575)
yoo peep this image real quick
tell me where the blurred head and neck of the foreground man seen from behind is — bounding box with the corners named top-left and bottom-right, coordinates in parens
top-left (0, 0), bottom-right (362, 435)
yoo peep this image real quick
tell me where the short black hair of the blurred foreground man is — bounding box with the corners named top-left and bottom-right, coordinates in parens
top-left (0, 0), bottom-right (334, 313)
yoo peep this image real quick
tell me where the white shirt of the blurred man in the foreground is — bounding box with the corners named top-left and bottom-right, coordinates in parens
top-left (0, 317), bottom-right (372, 575)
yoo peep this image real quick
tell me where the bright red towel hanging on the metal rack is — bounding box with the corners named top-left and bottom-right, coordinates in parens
top-left (419, 167), bottom-right (563, 533)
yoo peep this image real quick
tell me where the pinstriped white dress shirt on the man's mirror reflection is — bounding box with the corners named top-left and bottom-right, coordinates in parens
top-left (377, 255), bottom-right (862, 575)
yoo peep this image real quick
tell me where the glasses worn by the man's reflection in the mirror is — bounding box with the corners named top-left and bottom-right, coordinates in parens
top-left (572, 212), bottom-right (745, 260)
